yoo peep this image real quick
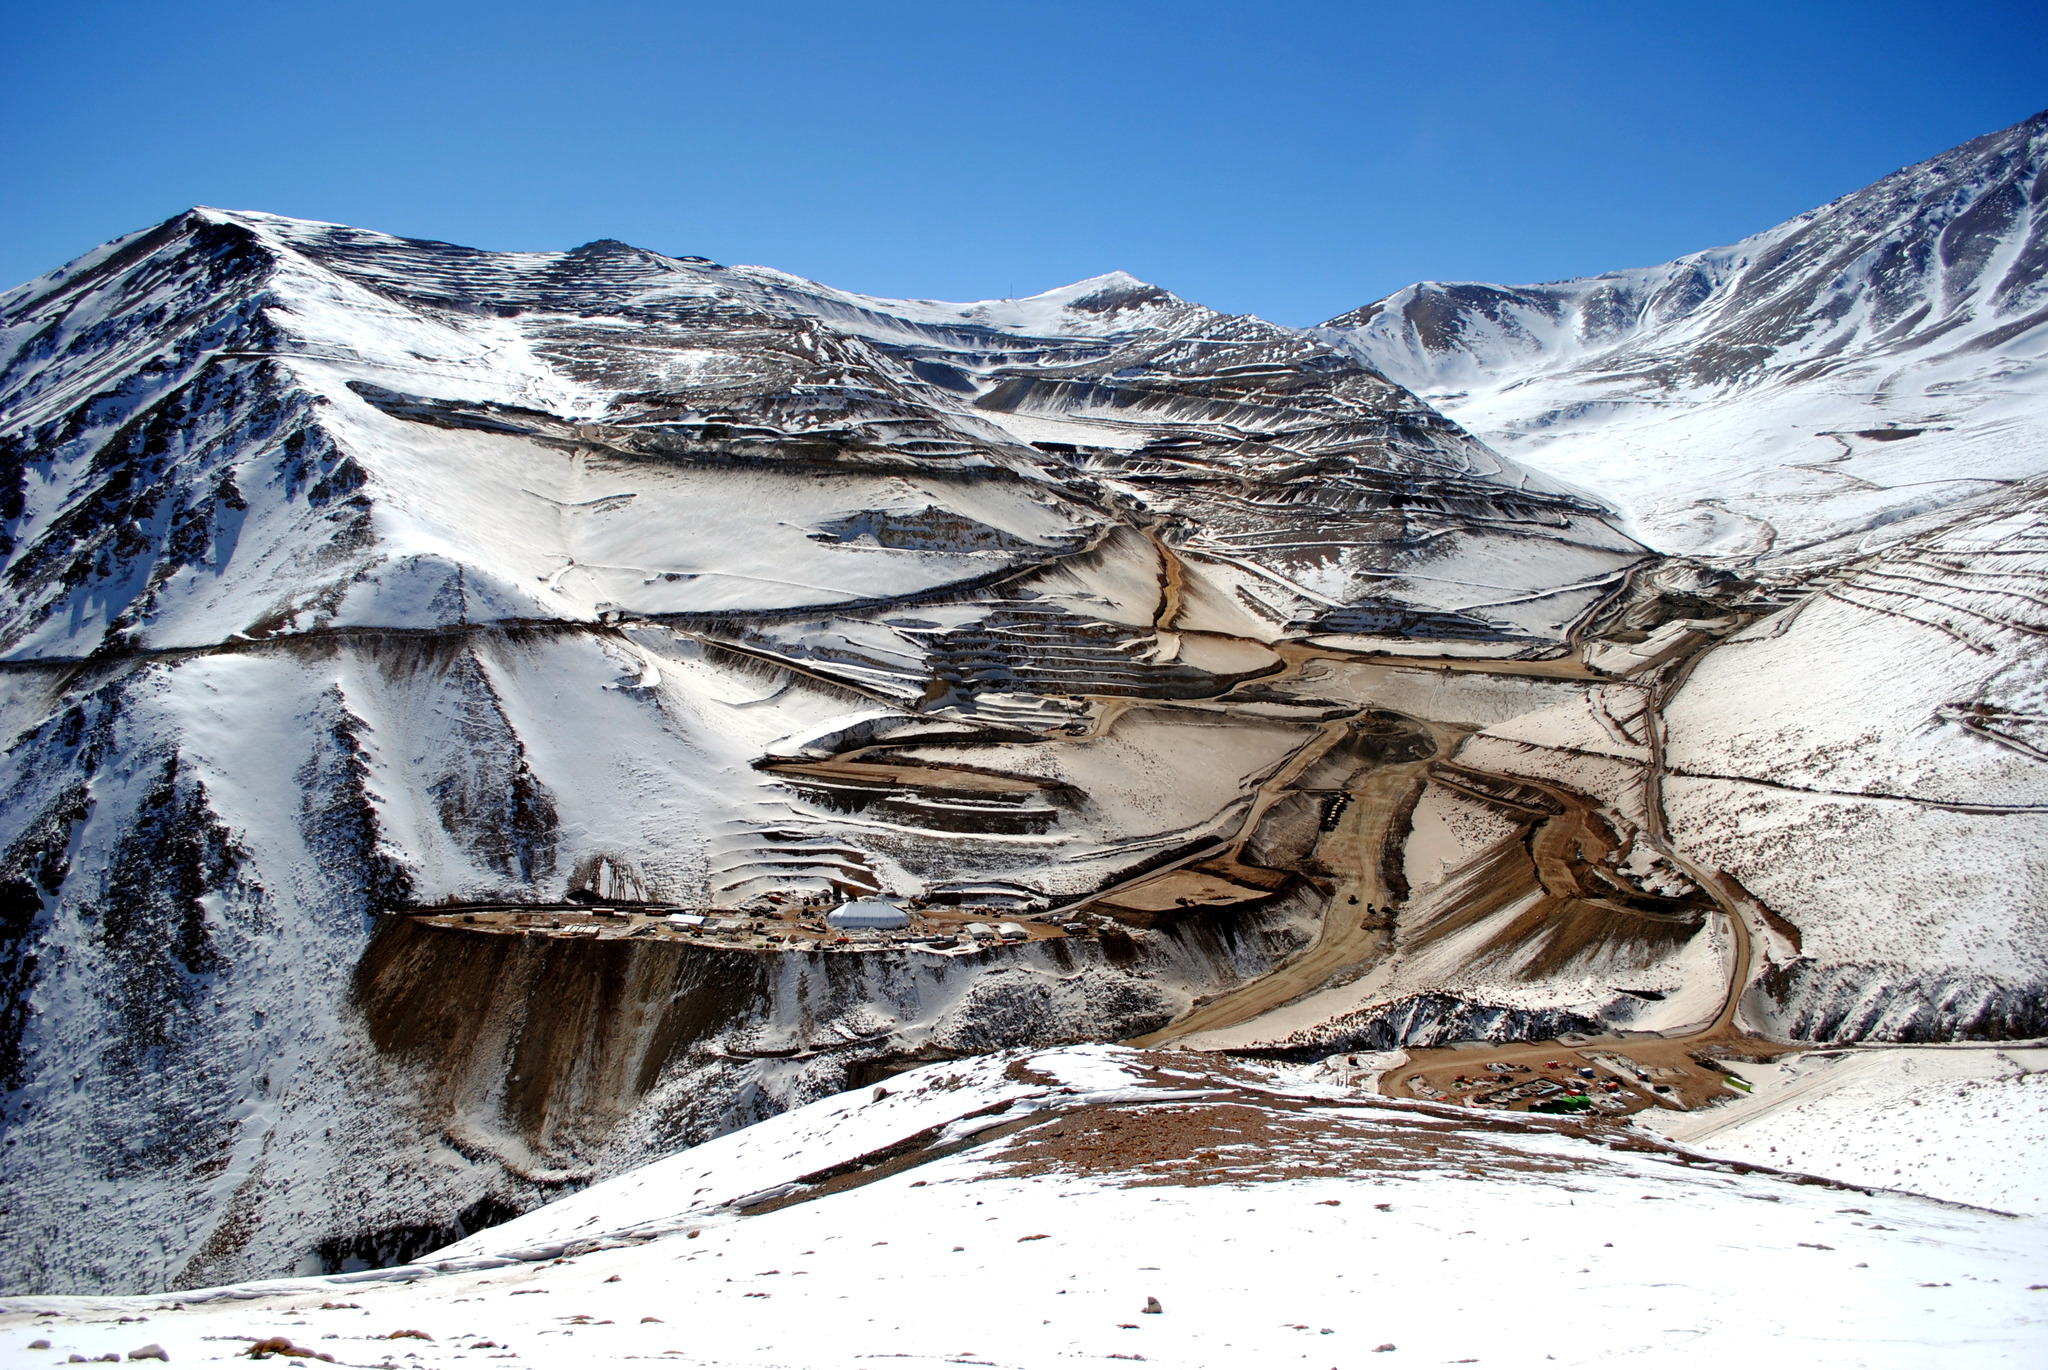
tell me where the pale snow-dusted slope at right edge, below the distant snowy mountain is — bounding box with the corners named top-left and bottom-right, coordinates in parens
top-left (1663, 481), bottom-right (2048, 1040)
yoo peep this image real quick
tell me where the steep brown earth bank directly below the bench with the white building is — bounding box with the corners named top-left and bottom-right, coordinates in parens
top-left (307, 880), bottom-right (1319, 1278)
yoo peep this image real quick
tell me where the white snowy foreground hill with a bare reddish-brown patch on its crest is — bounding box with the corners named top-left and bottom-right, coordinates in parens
top-left (0, 1046), bottom-right (2048, 1370)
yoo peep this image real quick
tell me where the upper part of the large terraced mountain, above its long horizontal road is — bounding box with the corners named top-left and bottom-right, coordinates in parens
top-left (0, 211), bottom-right (1636, 657)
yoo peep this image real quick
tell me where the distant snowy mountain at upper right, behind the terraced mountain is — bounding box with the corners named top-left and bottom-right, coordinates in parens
top-left (1315, 113), bottom-right (2048, 563)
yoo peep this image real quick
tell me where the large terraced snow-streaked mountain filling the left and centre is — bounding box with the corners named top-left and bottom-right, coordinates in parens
top-left (0, 211), bottom-right (1645, 1288)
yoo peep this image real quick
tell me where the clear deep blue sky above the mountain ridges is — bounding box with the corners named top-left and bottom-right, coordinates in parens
top-left (0, 0), bottom-right (2048, 324)
